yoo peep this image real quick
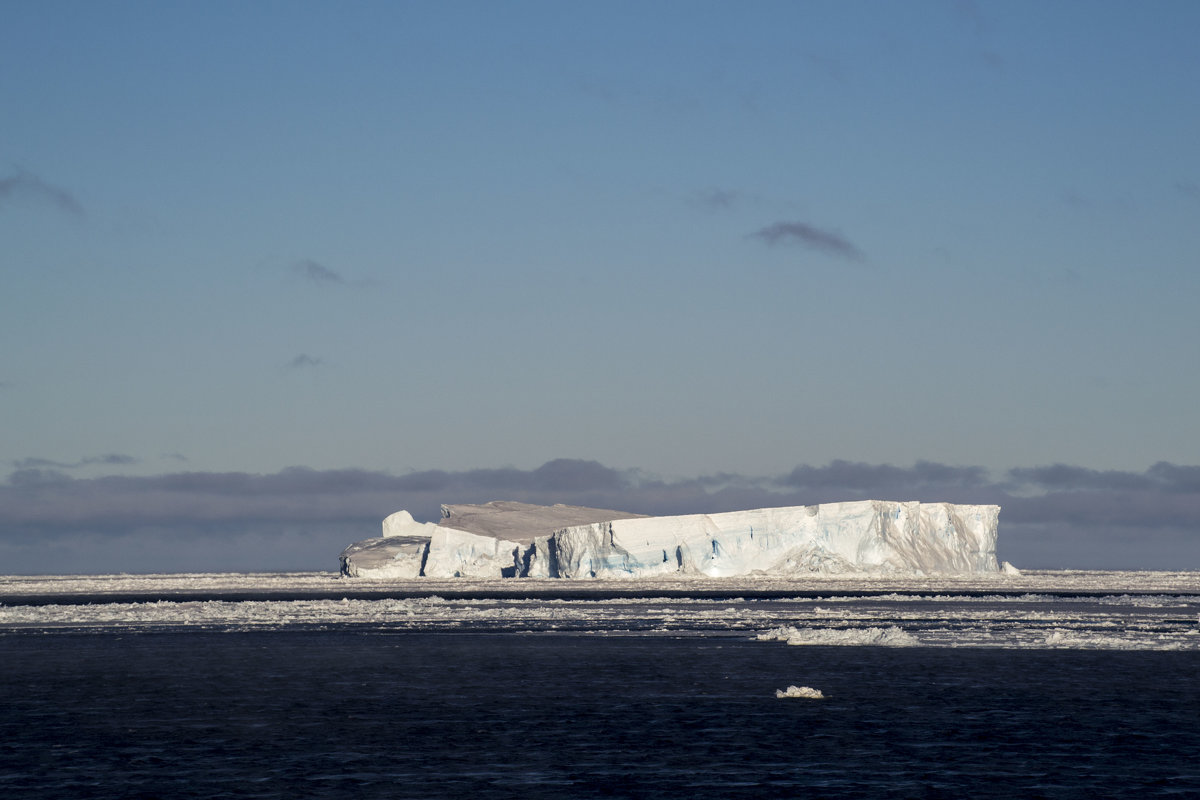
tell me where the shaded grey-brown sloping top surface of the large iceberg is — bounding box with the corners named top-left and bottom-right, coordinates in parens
top-left (440, 500), bottom-right (644, 545)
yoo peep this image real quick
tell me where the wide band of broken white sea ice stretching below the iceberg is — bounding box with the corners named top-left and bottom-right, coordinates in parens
top-left (0, 570), bottom-right (1200, 652)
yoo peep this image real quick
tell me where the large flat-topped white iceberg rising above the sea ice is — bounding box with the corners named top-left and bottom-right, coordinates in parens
top-left (341, 500), bottom-right (1000, 578)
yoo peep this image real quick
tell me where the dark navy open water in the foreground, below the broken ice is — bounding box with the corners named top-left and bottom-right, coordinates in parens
top-left (0, 630), bottom-right (1200, 799)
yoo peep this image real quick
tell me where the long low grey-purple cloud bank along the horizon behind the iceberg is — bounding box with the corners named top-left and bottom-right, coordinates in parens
top-left (0, 459), bottom-right (1200, 573)
